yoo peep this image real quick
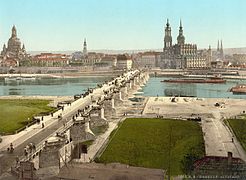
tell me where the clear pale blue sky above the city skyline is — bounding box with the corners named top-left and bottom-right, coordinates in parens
top-left (0, 0), bottom-right (246, 51)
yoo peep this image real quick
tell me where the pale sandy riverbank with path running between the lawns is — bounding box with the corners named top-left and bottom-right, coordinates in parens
top-left (143, 97), bottom-right (246, 161)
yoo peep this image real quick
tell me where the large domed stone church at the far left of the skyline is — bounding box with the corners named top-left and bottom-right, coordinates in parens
top-left (0, 26), bottom-right (27, 67)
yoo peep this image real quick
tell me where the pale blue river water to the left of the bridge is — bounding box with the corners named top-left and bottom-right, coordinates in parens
top-left (0, 76), bottom-right (112, 96)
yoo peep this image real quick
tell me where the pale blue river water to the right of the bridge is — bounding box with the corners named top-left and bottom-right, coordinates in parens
top-left (140, 77), bottom-right (246, 99)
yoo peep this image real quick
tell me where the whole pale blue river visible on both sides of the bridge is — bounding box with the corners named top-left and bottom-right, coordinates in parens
top-left (0, 76), bottom-right (246, 99)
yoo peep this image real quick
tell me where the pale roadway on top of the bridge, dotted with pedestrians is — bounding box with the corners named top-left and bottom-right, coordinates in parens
top-left (0, 70), bottom-right (142, 174)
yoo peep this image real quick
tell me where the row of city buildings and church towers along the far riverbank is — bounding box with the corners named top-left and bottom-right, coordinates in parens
top-left (0, 24), bottom-right (246, 69)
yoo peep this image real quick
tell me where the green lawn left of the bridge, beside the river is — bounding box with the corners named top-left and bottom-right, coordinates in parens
top-left (0, 99), bottom-right (54, 134)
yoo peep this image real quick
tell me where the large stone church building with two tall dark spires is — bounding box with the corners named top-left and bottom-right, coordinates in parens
top-left (159, 20), bottom-right (212, 69)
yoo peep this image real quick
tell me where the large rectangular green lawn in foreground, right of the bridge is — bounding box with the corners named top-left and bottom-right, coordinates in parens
top-left (98, 118), bottom-right (205, 175)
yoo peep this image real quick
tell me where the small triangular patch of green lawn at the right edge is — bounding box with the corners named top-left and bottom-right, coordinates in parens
top-left (227, 117), bottom-right (246, 151)
